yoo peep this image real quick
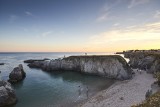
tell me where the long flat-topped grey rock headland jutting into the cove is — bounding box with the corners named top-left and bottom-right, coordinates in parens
top-left (28, 55), bottom-right (132, 80)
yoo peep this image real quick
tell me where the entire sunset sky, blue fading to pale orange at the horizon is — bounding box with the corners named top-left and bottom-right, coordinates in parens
top-left (0, 0), bottom-right (160, 52)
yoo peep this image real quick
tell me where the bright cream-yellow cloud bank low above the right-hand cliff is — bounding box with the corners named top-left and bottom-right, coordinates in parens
top-left (88, 22), bottom-right (160, 51)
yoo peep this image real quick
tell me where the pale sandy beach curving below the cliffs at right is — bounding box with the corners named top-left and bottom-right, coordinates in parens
top-left (79, 69), bottom-right (156, 107)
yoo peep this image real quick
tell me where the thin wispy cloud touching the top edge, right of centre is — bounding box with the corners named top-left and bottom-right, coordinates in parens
top-left (128, 0), bottom-right (150, 8)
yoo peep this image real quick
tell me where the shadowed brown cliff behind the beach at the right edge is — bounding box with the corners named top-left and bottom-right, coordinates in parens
top-left (124, 52), bottom-right (160, 72)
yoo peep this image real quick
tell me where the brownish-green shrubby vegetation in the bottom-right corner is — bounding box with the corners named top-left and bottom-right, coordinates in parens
top-left (131, 92), bottom-right (160, 107)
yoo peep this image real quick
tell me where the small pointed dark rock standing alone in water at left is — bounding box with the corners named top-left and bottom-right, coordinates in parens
top-left (9, 64), bottom-right (26, 83)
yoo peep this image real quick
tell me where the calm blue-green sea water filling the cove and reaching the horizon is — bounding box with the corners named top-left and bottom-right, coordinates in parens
top-left (0, 53), bottom-right (114, 107)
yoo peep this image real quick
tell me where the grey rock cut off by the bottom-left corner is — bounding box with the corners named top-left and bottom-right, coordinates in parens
top-left (0, 81), bottom-right (17, 107)
